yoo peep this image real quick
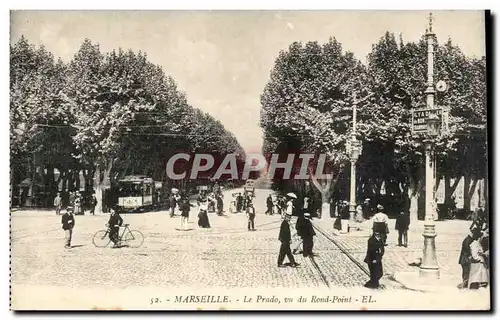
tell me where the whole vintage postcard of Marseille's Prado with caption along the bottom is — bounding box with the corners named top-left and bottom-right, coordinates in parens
top-left (10, 11), bottom-right (491, 311)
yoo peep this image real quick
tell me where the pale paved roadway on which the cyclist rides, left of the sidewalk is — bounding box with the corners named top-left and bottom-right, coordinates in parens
top-left (12, 190), bottom-right (367, 288)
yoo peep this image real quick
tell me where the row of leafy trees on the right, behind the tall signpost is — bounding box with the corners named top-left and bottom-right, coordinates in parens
top-left (261, 33), bottom-right (487, 219)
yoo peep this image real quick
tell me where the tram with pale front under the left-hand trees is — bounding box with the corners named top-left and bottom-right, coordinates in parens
top-left (115, 176), bottom-right (156, 211)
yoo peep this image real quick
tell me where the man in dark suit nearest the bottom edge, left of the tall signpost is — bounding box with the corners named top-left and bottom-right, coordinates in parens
top-left (364, 232), bottom-right (384, 289)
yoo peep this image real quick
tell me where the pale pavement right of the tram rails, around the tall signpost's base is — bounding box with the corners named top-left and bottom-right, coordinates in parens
top-left (313, 218), bottom-right (470, 291)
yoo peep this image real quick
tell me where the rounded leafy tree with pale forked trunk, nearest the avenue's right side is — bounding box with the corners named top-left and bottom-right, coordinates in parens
top-left (261, 38), bottom-right (368, 214)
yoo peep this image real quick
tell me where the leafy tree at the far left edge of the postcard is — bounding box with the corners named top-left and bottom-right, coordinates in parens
top-left (10, 37), bottom-right (72, 202)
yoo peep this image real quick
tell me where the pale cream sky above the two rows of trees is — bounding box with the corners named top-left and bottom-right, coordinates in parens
top-left (10, 11), bottom-right (485, 153)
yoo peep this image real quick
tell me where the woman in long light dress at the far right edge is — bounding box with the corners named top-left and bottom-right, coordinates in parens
top-left (469, 229), bottom-right (489, 289)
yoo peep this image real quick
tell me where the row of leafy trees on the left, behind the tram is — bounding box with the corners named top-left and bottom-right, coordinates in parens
top-left (10, 38), bottom-right (244, 210)
